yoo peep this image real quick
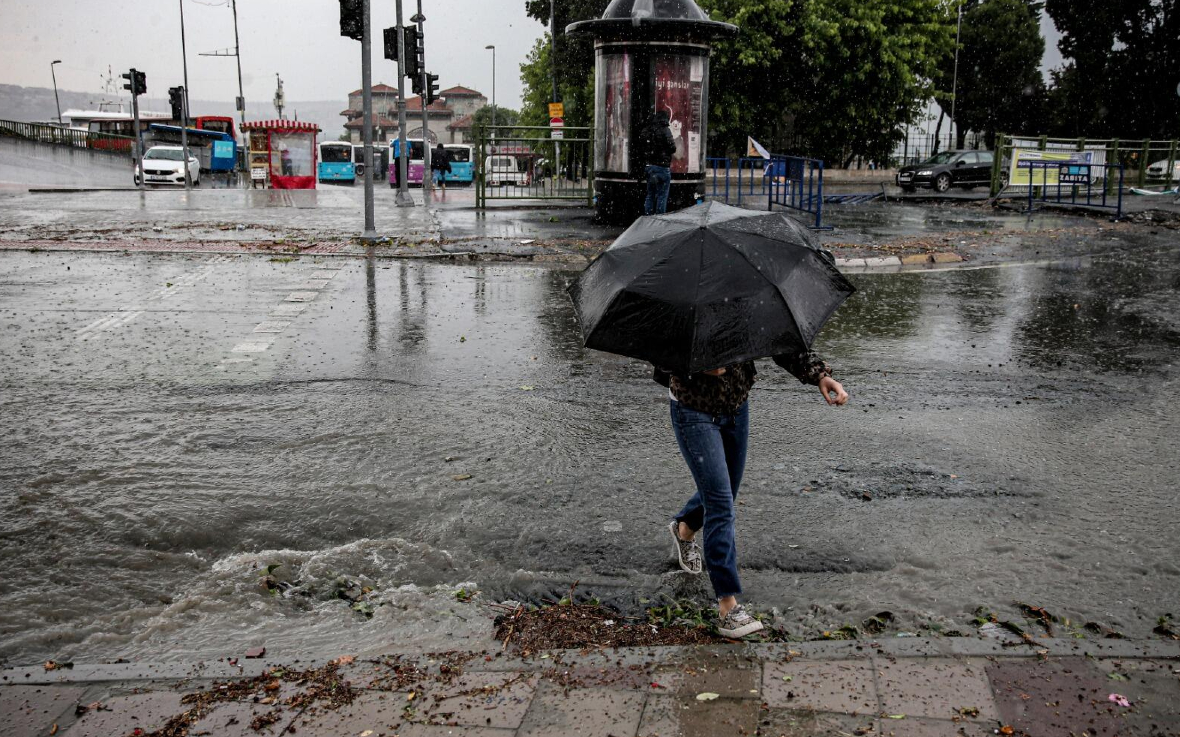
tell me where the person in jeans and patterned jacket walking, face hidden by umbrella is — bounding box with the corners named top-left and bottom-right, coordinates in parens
top-left (653, 350), bottom-right (848, 638)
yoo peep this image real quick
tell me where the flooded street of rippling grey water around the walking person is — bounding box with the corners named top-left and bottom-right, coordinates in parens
top-left (0, 244), bottom-right (1180, 664)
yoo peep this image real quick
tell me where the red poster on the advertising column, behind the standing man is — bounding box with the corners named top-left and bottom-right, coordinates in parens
top-left (654, 54), bottom-right (706, 175)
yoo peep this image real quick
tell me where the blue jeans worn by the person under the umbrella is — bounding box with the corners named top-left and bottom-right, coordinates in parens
top-left (671, 400), bottom-right (749, 599)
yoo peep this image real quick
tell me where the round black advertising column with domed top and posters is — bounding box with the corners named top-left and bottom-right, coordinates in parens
top-left (565, 0), bottom-right (738, 223)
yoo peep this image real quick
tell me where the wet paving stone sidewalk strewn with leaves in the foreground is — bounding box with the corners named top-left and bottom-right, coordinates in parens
top-left (0, 638), bottom-right (1180, 737)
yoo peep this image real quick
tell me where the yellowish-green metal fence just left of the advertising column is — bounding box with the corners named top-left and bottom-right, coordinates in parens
top-left (476, 126), bottom-right (594, 208)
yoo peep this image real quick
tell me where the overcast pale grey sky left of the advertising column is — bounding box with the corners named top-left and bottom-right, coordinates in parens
top-left (0, 0), bottom-right (545, 107)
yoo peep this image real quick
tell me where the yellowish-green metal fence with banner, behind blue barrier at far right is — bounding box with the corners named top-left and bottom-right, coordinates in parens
top-left (991, 133), bottom-right (1180, 197)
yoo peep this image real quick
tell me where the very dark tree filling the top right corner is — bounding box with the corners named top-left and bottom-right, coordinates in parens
top-left (1045, 0), bottom-right (1180, 138)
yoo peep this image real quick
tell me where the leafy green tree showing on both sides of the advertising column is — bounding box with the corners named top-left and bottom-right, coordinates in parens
top-left (522, 0), bottom-right (955, 165)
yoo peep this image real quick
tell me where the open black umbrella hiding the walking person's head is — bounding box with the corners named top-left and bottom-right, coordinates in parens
top-left (570, 202), bottom-right (856, 375)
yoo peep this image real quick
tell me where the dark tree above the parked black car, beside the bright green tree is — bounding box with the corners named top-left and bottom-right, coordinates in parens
top-left (936, 0), bottom-right (1044, 149)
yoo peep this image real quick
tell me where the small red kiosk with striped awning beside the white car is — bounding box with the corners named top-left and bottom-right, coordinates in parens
top-left (240, 120), bottom-right (320, 190)
